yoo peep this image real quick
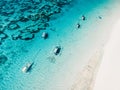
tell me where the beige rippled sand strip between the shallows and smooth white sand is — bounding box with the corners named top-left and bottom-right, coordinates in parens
top-left (71, 48), bottom-right (103, 90)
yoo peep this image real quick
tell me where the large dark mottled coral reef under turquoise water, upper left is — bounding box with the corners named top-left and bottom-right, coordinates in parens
top-left (0, 0), bottom-right (72, 44)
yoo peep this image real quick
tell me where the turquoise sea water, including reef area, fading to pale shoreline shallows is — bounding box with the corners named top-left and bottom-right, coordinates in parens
top-left (0, 0), bottom-right (119, 90)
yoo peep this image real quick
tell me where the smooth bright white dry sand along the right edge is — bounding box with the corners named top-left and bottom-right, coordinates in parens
top-left (94, 20), bottom-right (120, 90)
